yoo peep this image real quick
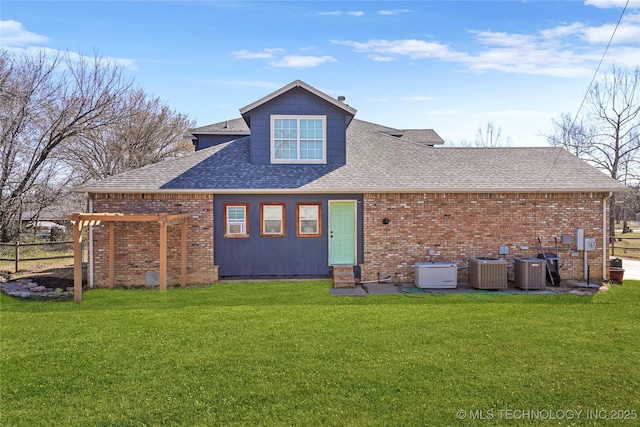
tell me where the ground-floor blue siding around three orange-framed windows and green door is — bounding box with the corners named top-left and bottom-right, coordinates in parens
top-left (213, 194), bottom-right (363, 278)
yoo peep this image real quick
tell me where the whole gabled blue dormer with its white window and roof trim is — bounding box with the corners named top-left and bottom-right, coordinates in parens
top-left (240, 80), bottom-right (356, 165)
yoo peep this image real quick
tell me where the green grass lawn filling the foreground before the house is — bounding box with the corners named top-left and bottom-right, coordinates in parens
top-left (0, 281), bottom-right (640, 426)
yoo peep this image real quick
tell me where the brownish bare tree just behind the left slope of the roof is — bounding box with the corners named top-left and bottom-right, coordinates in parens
top-left (62, 89), bottom-right (195, 183)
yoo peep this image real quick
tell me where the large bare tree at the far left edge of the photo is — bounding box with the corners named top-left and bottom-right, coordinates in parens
top-left (0, 50), bottom-right (130, 241)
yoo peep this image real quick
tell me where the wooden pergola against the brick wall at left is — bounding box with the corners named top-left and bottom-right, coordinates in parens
top-left (67, 213), bottom-right (191, 303)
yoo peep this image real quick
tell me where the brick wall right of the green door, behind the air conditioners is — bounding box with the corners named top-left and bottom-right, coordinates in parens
top-left (361, 193), bottom-right (608, 282)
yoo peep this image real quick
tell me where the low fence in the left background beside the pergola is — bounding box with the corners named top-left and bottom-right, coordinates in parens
top-left (0, 240), bottom-right (79, 272)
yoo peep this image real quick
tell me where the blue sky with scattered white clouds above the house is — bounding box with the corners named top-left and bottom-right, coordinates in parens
top-left (0, 0), bottom-right (640, 146)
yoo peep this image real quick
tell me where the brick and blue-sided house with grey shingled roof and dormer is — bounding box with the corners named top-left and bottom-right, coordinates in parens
top-left (78, 80), bottom-right (625, 292)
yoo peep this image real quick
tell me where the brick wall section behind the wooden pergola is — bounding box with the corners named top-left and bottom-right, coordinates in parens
top-left (91, 194), bottom-right (218, 287)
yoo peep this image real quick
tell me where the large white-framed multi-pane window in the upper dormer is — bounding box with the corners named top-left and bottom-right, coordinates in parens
top-left (271, 116), bottom-right (327, 163)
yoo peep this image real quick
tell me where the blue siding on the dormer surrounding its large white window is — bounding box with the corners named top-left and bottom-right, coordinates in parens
top-left (242, 88), bottom-right (351, 165)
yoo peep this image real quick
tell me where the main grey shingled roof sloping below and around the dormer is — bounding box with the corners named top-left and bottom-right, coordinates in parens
top-left (77, 119), bottom-right (626, 193)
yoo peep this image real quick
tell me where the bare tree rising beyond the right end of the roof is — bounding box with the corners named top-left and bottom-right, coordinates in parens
top-left (547, 66), bottom-right (640, 236)
